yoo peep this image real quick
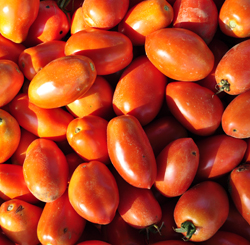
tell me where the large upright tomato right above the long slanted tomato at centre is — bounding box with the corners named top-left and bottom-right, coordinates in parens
top-left (113, 55), bottom-right (167, 126)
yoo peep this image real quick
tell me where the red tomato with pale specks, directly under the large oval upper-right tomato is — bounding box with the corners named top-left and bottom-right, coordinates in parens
top-left (166, 81), bottom-right (224, 136)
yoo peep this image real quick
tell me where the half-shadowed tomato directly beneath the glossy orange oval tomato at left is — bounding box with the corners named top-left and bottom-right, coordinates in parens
top-left (9, 93), bottom-right (74, 141)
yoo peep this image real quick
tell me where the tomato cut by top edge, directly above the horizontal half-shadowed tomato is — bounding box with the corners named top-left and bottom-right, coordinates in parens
top-left (82, 0), bottom-right (129, 30)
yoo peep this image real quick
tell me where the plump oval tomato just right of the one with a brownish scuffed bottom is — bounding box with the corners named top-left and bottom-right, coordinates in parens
top-left (68, 161), bottom-right (119, 224)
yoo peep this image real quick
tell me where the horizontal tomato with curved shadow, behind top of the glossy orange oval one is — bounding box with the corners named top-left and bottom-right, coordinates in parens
top-left (65, 29), bottom-right (133, 75)
